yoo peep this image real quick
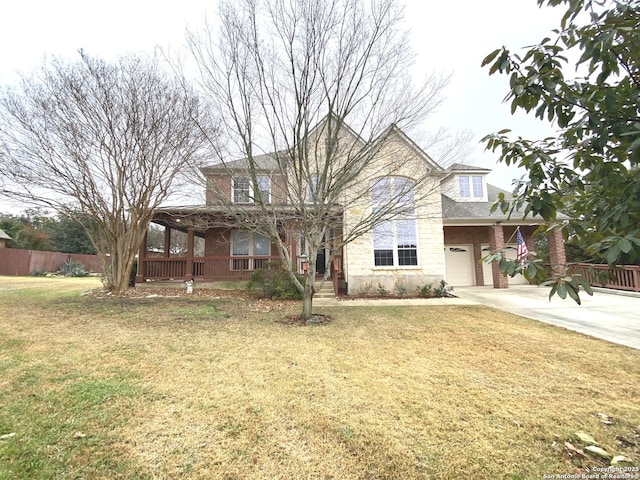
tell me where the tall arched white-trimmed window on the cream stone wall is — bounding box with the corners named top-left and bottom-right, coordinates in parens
top-left (372, 177), bottom-right (418, 267)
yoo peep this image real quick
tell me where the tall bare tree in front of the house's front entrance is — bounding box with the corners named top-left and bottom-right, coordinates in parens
top-left (188, 0), bottom-right (447, 319)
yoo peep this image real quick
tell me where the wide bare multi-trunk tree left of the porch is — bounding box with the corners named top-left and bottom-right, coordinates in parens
top-left (0, 51), bottom-right (211, 292)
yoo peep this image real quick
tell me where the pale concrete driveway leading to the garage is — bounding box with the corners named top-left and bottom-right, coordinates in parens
top-left (453, 285), bottom-right (640, 350)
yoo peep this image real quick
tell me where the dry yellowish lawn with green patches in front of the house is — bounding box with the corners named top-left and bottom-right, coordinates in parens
top-left (0, 277), bottom-right (640, 479)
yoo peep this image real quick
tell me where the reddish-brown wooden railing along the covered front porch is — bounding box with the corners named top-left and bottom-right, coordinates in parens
top-left (139, 256), bottom-right (280, 280)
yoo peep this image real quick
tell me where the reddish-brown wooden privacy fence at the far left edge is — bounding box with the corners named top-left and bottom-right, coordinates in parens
top-left (0, 248), bottom-right (100, 276)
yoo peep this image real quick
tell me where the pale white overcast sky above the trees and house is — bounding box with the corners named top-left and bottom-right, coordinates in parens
top-left (0, 0), bottom-right (560, 210)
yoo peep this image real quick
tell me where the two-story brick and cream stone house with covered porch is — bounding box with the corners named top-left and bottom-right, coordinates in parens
top-left (136, 120), bottom-right (566, 293)
